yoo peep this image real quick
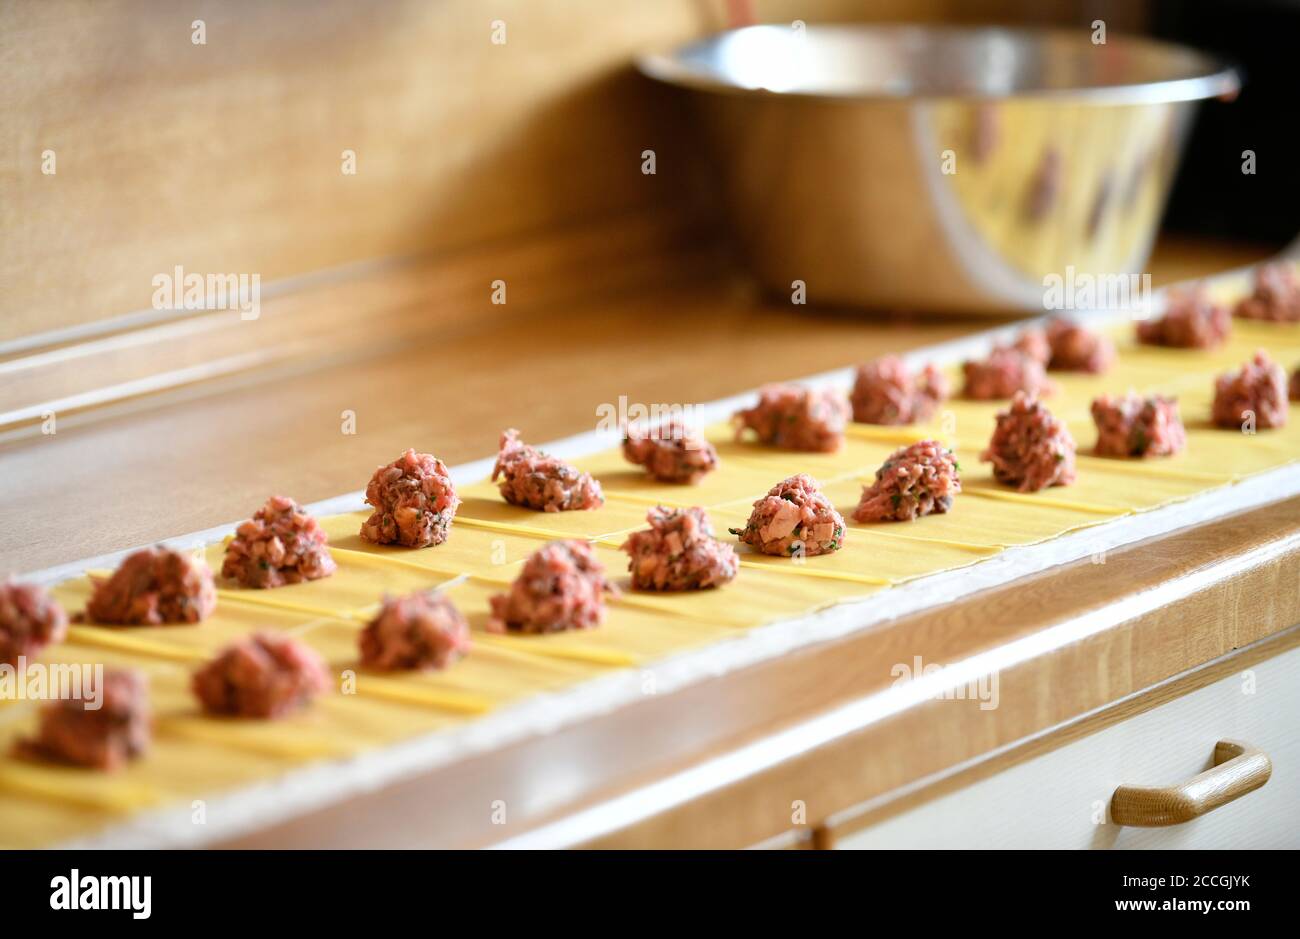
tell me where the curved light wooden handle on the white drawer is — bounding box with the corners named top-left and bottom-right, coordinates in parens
top-left (1110, 740), bottom-right (1273, 828)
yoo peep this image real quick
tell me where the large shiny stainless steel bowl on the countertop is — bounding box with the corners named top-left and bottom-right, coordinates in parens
top-left (640, 26), bottom-right (1239, 312)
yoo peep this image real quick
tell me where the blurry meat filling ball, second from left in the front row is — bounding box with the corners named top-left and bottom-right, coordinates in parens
top-left (191, 633), bottom-right (329, 718)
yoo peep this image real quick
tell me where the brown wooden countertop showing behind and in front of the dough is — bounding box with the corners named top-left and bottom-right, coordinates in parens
top-left (0, 228), bottom-right (1300, 847)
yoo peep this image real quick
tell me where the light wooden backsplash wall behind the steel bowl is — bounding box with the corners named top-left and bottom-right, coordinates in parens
top-left (0, 0), bottom-right (1139, 349)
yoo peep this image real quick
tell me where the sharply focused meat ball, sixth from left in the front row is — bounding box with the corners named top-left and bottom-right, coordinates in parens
top-left (728, 473), bottom-right (844, 558)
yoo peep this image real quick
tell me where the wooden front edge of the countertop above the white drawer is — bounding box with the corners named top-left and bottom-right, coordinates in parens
top-left (218, 498), bottom-right (1300, 848)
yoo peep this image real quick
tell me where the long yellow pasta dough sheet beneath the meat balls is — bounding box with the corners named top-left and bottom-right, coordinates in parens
top-left (0, 310), bottom-right (1300, 848)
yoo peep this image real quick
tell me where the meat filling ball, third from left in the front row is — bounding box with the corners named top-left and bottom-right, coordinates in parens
top-left (360, 592), bottom-right (469, 671)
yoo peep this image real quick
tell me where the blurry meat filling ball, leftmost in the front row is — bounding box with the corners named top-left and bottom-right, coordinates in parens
top-left (18, 668), bottom-right (151, 770)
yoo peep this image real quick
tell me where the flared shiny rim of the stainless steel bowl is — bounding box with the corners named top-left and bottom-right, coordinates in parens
top-left (636, 23), bottom-right (1242, 104)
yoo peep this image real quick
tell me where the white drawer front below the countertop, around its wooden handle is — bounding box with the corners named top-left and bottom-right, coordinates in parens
top-left (835, 639), bottom-right (1300, 848)
